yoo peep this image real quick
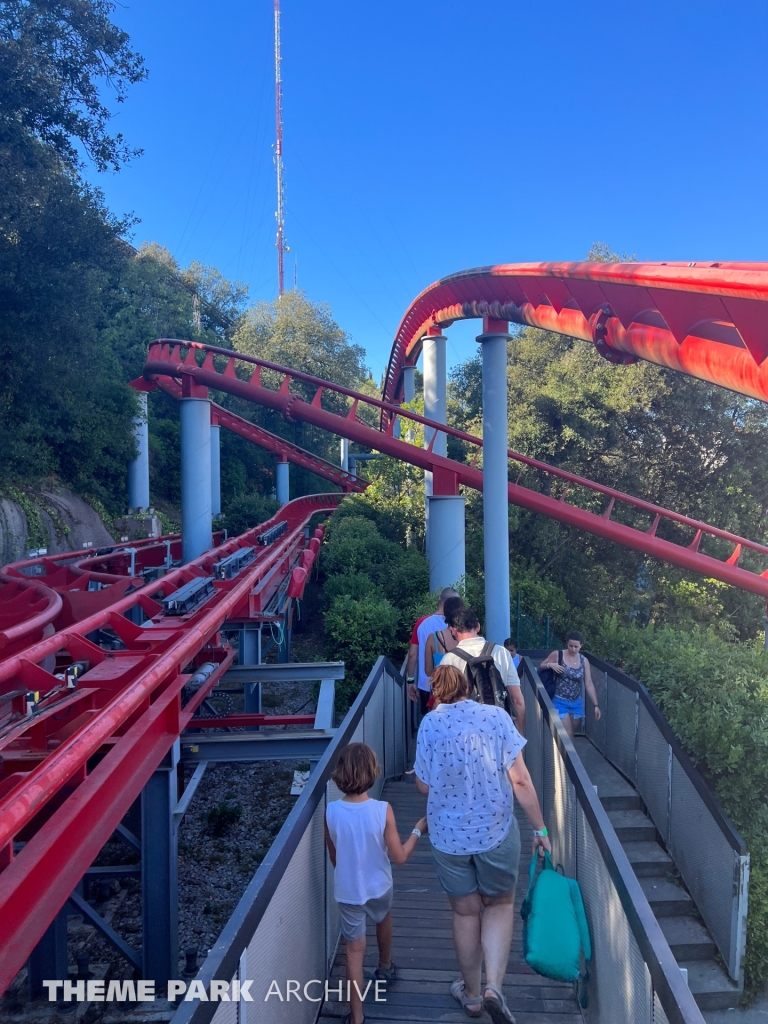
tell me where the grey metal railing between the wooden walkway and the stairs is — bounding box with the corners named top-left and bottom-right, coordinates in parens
top-left (520, 657), bottom-right (703, 1024)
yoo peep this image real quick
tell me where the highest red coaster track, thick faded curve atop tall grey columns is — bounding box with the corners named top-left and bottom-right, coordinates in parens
top-left (383, 262), bottom-right (768, 401)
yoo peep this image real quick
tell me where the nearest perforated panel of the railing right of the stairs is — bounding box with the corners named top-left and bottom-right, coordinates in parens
top-left (669, 757), bottom-right (738, 964)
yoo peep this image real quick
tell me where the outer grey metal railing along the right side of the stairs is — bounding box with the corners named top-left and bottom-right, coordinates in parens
top-left (585, 654), bottom-right (750, 986)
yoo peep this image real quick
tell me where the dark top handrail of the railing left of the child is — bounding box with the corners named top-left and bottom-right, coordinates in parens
top-left (173, 654), bottom-right (404, 1024)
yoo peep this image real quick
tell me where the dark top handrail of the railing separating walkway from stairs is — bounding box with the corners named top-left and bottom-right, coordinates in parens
top-left (521, 651), bottom-right (703, 1024)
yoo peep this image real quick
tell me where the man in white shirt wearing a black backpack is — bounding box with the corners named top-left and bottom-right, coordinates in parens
top-left (440, 608), bottom-right (525, 735)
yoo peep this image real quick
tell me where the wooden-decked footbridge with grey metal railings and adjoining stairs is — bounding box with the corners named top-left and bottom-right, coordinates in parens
top-left (166, 657), bottom-right (748, 1024)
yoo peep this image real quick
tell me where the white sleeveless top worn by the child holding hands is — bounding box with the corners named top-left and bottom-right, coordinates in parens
top-left (326, 800), bottom-right (392, 906)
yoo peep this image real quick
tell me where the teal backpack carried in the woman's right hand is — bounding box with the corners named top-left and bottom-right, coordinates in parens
top-left (520, 852), bottom-right (592, 1007)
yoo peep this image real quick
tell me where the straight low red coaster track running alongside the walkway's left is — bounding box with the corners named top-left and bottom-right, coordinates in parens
top-left (0, 494), bottom-right (342, 991)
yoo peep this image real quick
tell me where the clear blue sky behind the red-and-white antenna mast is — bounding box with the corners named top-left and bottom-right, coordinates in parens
top-left (94, 0), bottom-right (768, 379)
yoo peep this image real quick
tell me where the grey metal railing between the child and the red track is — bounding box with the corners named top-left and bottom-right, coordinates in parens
top-left (173, 657), bottom-right (408, 1024)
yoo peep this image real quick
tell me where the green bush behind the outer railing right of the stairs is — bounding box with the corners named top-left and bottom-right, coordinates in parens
top-left (589, 616), bottom-right (768, 993)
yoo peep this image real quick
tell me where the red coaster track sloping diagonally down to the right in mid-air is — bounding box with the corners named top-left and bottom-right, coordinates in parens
top-left (144, 341), bottom-right (768, 598)
